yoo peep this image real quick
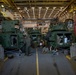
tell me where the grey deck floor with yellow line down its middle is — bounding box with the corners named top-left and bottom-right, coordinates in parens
top-left (0, 49), bottom-right (75, 75)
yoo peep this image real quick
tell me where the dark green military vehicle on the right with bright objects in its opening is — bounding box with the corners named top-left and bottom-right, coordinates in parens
top-left (46, 19), bottom-right (73, 49)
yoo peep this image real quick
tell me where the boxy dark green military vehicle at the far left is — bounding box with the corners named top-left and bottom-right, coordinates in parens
top-left (0, 20), bottom-right (24, 49)
